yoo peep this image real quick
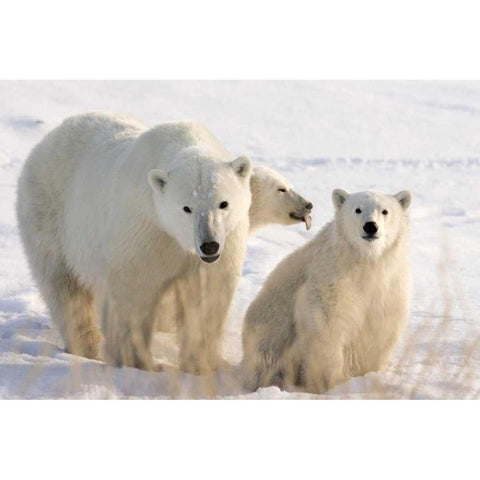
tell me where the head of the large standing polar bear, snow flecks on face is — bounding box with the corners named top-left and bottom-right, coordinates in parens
top-left (148, 152), bottom-right (252, 263)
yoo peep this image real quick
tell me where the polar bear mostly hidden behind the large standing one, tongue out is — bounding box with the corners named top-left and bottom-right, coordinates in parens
top-left (156, 165), bottom-right (313, 332)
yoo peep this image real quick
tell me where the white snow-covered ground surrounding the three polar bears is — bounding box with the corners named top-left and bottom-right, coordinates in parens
top-left (0, 81), bottom-right (480, 398)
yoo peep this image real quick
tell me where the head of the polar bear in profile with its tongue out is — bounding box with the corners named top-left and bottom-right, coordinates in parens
top-left (250, 166), bottom-right (313, 230)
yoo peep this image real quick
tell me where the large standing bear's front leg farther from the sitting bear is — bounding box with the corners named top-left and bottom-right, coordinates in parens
top-left (102, 228), bottom-right (186, 370)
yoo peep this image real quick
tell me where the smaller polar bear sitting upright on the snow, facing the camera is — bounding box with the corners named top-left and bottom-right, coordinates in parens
top-left (242, 189), bottom-right (412, 392)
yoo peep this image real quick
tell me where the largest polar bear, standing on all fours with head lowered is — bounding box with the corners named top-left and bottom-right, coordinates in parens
top-left (17, 113), bottom-right (251, 369)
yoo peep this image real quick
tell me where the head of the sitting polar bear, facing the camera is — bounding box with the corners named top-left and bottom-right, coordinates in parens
top-left (332, 189), bottom-right (412, 256)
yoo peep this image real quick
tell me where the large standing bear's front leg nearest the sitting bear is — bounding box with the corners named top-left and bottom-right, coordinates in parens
top-left (176, 221), bottom-right (248, 374)
